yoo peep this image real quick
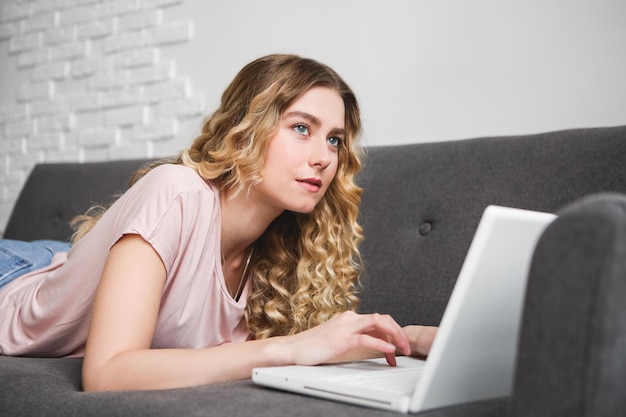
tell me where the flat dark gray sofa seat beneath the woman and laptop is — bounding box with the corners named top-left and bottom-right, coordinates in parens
top-left (0, 357), bottom-right (506, 417)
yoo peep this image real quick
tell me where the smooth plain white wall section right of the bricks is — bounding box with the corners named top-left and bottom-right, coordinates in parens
top-left (160, 0), bottom-right (626, 144)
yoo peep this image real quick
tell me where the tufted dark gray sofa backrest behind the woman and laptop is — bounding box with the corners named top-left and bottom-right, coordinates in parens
top-left (5, 126), bottom-right (626, 324)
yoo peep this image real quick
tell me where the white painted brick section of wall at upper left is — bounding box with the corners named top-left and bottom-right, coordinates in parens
top-left (0, 0), bottom-right (205, 233)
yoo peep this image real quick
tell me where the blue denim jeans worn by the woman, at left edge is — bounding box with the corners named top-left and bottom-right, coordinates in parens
top-left (0, 239), bottom-right (71, 289)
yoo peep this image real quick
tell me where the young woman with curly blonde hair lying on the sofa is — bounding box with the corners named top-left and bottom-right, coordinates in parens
top-left (0, 55), bottom-right (435, 390)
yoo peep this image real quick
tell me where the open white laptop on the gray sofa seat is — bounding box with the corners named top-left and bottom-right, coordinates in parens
top-left (252, 206), bottom-right (555, 413)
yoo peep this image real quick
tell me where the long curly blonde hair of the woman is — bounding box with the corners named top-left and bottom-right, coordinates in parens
top-left (75, 55), bottom-right (362, 339)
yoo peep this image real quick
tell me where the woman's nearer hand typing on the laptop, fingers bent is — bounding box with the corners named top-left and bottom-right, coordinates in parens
top-left (283, 311), bottom-right (411, 366)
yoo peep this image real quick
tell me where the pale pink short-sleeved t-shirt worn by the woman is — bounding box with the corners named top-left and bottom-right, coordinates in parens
top-left (0, 165), bottom-right (248, 357)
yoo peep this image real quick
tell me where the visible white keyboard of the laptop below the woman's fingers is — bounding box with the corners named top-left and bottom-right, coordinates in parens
top-left (324, 368), bottom-right (422, 394)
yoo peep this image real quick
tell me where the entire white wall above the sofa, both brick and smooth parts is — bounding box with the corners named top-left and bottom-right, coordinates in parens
top-left (0, 0), bottom-right (626, 232)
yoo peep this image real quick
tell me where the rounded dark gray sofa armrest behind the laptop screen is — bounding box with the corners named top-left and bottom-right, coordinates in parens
top-left (510, 194), bottom-right (626, 417)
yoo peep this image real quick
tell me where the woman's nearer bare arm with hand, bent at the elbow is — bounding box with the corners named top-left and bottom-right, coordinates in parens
top-left (83, 235), bottom-right (410, 391)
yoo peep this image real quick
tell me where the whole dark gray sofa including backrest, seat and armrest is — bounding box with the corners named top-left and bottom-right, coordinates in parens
top-left (0, 127), bottom-right (626, 417)
